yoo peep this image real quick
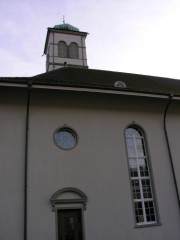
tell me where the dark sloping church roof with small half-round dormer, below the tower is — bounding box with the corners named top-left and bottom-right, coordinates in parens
top-left (0, 67), bottom-right (180, 96)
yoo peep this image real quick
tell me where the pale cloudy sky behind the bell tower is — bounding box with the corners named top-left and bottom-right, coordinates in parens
top-left (0, 0), bottom-right (180, 79)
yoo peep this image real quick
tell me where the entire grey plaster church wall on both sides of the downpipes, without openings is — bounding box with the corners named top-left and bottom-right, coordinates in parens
top-left (0, 87), bottom-right (180, 240)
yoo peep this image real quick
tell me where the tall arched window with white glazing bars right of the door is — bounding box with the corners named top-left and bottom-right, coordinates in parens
top-left (125, 125), bottom-right (157, 225)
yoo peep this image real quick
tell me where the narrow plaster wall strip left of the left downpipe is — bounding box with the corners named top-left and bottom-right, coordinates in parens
top-left (0, 87), bottom-right (26, 240)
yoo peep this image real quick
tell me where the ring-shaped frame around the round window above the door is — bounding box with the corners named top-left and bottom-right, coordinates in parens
top-left (53, 126), bottom-right (78, 151)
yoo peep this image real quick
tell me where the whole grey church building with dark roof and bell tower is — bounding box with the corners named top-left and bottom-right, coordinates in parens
top-left (0, 22), bottom-right (180, 240)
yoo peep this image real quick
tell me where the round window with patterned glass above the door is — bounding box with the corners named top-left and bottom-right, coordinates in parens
top-left (54, 128), bottom-right (77, 150)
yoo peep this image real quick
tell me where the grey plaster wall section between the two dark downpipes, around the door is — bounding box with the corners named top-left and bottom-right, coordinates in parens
top-left (28, 90), bottom-right (180, 240)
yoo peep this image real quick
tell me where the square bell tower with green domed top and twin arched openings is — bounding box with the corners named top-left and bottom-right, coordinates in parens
top-left (44, 20), bottom-right (88, 72)
